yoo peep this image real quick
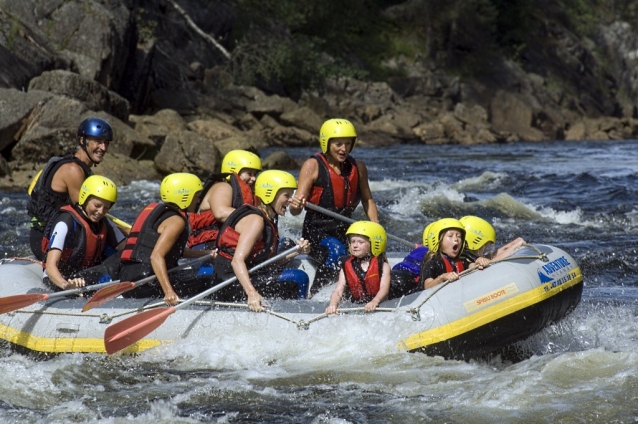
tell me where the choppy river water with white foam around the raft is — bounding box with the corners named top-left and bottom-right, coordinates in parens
top-left (0, 141), bottom-right (638, 424)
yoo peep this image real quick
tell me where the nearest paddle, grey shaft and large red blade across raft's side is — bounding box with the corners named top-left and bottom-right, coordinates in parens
top-left (104, 246), bottom-right (299, 355)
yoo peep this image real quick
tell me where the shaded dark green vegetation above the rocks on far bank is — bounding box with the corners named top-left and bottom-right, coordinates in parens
top-left (214, 0), bottom-right (638, 98)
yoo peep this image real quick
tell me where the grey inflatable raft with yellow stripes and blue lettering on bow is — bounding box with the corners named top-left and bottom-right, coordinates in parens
top-left (0, 245), bottom-right (583, 360)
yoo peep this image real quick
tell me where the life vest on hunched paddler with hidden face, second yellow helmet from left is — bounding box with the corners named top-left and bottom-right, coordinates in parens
top-left (120, 203), bottom-right (188, 268)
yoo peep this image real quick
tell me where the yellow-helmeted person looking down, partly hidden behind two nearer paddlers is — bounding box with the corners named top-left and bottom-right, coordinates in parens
top-left (188, 150), bottom-right (261, 249)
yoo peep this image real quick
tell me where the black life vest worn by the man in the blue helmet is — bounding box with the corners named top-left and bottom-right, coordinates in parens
top-left (27, 155), bottom-right (93, 229)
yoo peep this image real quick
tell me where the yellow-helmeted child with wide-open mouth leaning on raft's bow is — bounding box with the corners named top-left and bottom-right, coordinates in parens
top-left (421, 218), bottom-right (490, 289)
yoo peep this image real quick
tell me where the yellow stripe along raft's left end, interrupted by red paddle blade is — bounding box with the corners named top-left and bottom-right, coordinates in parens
top-left (0, 324), bottom-right (170, 353)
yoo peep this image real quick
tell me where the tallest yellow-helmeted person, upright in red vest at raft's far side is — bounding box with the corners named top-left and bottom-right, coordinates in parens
top-left (290, 118), bottom-right (379, 288)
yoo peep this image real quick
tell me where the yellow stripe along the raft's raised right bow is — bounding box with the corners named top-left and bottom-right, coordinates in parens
top-left (398, 267), bottom-right (583, 351)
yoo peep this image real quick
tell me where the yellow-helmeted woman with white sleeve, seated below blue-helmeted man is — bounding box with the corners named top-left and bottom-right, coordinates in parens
top-left (42, 175), bottom-right (125, 290)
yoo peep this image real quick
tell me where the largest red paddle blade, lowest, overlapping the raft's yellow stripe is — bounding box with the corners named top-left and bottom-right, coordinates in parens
top-left (104, 306), bottom-right (176, 355)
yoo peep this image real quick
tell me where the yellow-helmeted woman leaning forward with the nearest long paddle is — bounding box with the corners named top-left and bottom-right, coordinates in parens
top-left (213, 170), bottom-right (310, 312)
